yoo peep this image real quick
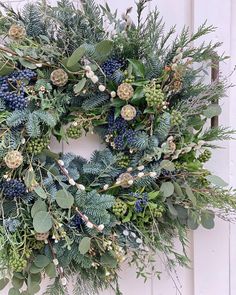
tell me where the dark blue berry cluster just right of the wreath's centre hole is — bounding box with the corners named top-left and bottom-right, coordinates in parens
top-left (107, 113), bottom-right (136, 150)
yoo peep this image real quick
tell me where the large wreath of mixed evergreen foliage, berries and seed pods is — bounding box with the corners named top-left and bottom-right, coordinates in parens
top-left (0, 0), bottom-right (236, 295)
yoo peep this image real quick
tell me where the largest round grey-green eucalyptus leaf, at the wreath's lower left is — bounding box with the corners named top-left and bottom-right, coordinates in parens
top-left (33, 211), bottom-right (52, 233)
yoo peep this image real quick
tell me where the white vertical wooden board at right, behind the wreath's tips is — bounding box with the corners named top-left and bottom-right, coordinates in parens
top-left (193, 0), bottom-right (231, 295)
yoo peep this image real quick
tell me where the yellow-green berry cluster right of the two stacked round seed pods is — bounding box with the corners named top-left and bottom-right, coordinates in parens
top-left (144, 82), bottom-right (167, 110)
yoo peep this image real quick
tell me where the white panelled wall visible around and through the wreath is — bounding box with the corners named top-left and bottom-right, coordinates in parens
top-left (2, 0), bottom-right (236, 295)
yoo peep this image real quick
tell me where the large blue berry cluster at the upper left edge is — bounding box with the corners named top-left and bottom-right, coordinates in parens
top-left (0, 69), bottom-right (36, 110)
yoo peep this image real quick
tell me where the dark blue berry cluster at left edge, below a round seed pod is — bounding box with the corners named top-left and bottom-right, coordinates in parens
top-left (0, 179), bottom-right (27, 199)
